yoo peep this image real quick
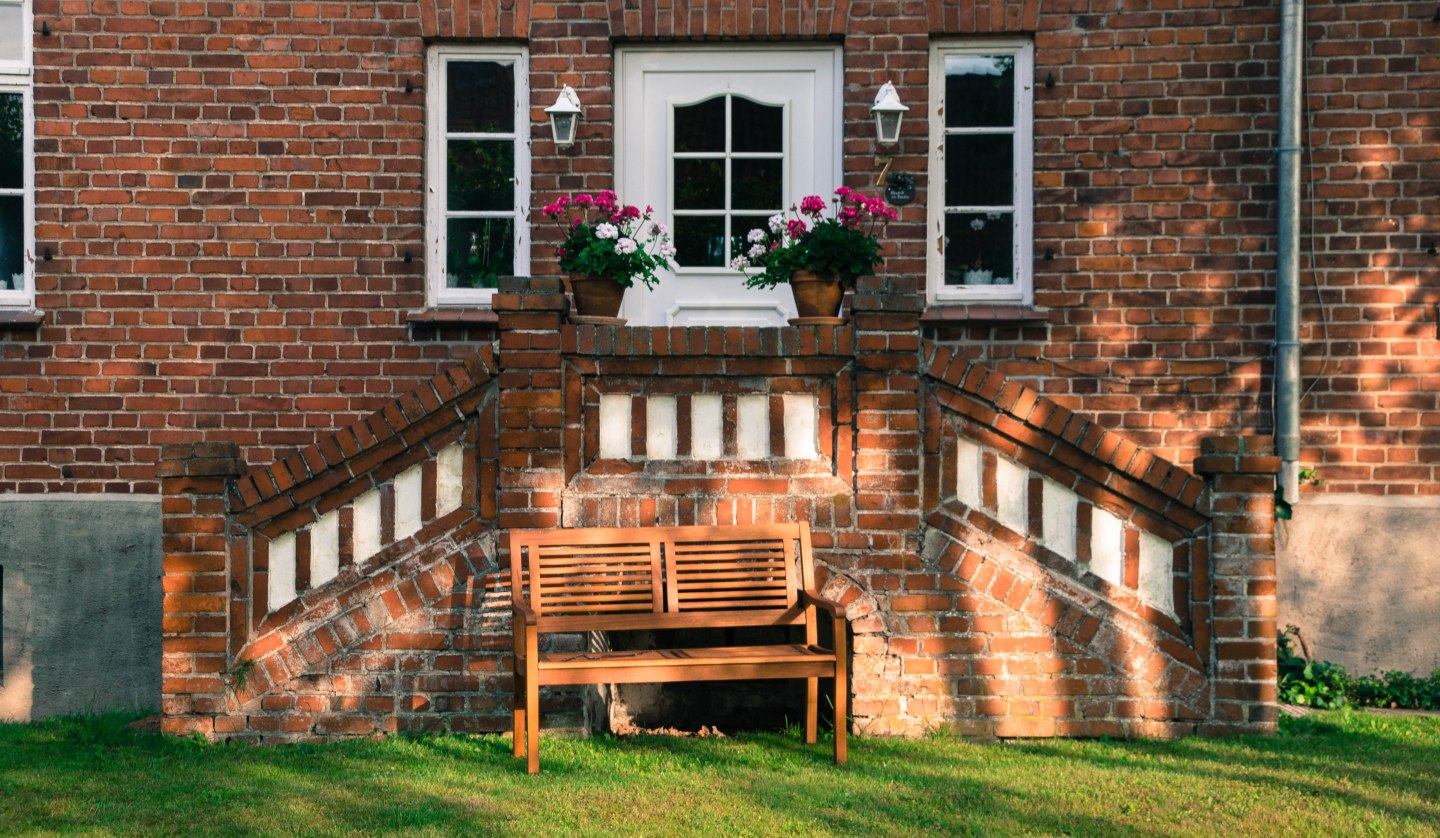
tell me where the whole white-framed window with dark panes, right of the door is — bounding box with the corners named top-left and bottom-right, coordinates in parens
top-left (929, 40), bottom-right (1034, 302)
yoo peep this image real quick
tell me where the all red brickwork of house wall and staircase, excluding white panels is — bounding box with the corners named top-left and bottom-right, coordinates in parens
top-left (8, 0), bottom-right (1440, 736)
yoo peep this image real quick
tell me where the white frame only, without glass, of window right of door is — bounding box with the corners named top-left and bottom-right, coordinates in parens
top-left (926, 39), bottom-right (1035, 305)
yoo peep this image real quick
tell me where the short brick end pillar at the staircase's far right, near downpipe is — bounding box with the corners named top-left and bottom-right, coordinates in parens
top-left (1195, 436), bottom-right (1280, 733)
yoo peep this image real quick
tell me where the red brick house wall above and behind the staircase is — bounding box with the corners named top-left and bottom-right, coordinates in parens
top-left (0, 0), bottom-right (1440, 494)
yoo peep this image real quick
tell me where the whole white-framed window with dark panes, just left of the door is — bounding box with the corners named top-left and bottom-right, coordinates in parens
top-left (426, 46), bottom-right (530, 305)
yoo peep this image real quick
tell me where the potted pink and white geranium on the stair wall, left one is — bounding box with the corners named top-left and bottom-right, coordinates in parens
top-left (540, 190), bottom-right (675, 317)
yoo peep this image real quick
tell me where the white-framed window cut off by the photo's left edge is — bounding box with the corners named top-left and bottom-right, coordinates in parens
top-left (0, 0), bottom-right (35, 308)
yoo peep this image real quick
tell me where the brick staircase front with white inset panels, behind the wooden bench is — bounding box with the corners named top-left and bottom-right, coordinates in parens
top-left (164, 279), bottom-right (1277, 740)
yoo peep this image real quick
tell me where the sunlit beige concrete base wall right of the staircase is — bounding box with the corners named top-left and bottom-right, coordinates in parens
top-left (1276, 495), bottom-right (1440, 675)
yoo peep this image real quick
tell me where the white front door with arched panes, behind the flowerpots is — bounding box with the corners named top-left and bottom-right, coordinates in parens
top-left (615, 48), bottom-right (842, 325)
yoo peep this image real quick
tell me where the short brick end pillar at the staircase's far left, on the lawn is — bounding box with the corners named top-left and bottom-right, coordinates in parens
top-left (157, 442), bottom-right (243, 736)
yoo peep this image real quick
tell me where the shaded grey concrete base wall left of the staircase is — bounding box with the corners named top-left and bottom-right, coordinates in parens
top-left (0, 495), bottom-right (161, 721)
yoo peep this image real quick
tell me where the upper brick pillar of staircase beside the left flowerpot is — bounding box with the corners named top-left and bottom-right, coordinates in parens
top-left (492, 276), bottom-right (566, 530)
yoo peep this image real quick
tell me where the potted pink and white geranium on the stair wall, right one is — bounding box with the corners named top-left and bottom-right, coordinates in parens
top-left (730, 186), bottom-right (896, 318)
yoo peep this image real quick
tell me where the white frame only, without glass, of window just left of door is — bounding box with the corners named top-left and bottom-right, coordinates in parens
top-left (425, 45), bottom-right (530, 307)
